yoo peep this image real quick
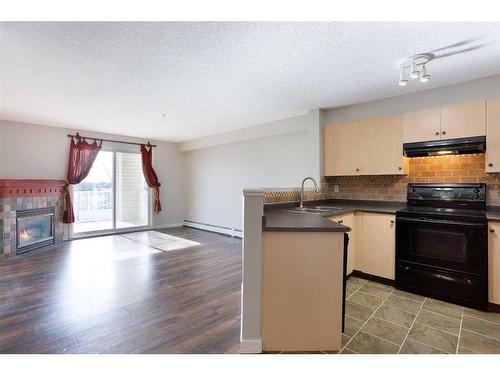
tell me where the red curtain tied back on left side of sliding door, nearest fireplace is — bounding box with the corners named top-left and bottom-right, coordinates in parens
top-left (63, 137), bottom-right (102, 224)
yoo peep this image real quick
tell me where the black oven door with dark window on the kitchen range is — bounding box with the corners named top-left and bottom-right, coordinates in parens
top-left (396, 217), bottom-right (487, 275)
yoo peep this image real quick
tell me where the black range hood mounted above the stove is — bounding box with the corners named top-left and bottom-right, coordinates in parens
top-left (403, 136), bottom-right (486, 158)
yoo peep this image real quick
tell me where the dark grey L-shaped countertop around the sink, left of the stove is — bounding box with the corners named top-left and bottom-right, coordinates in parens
top-left (262, 199), bottom-right (404, 232)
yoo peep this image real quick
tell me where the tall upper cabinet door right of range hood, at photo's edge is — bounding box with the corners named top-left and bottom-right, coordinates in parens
top-left (485, 98), bottom-right (500, 173)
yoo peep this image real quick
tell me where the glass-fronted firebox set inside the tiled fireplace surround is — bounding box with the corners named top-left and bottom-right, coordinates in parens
top-left (16, 208), bottom-right (54, 254)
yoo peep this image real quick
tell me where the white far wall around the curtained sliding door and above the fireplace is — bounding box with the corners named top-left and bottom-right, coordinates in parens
top-left (0, 120), bottom-right (184, 226)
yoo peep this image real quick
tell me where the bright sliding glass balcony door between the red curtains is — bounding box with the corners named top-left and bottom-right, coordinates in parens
top-left (73, 151), bottom-right (150, 235)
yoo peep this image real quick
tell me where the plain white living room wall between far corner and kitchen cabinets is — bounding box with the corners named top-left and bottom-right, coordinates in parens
top-left (181, 111), bottom-right (321, 229)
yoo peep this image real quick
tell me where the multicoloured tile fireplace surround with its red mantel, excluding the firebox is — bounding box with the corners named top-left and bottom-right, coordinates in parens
top-left (0, 180), bottom-right (65, 258)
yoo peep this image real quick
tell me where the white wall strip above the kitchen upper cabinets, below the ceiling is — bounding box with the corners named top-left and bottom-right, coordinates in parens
top-left (323, 74), bottom-right (500, 125)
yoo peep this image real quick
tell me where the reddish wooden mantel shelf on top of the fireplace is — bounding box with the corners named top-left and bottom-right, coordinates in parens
top-left (0, 179), bottom-right (66, 198)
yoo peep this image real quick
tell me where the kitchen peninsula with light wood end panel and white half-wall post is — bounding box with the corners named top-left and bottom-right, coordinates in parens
top-left (241, 189), bottom-right (350, 353)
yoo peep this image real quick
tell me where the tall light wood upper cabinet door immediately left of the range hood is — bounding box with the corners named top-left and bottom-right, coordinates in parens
top-left (371, 114), bottom-right (408, 175)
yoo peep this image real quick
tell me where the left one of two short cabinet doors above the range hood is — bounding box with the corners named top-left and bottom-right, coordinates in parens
top-left (403, 108), bottom-right (441, 143)
